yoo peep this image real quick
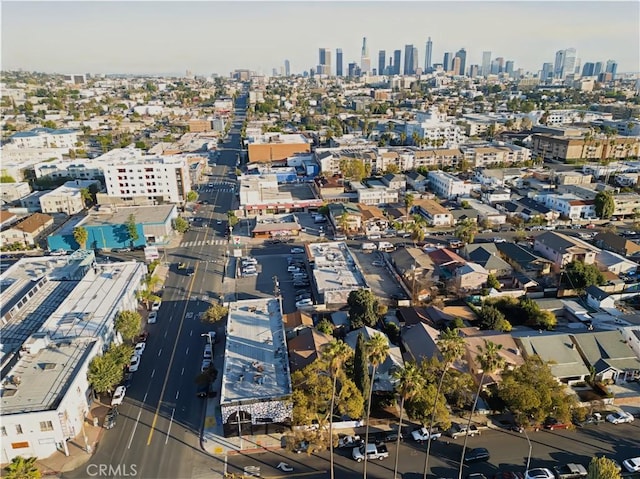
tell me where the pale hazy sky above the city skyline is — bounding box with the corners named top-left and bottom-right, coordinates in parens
top-left (1, 0), bottom-right (640, 75)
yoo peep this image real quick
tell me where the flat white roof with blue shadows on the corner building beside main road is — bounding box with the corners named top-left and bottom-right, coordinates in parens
top-left (220, 298), bottom-right (291, 405)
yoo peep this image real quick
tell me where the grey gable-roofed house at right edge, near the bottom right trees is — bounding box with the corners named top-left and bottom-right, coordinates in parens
top-left (572, 331), bottom-right (640, 384)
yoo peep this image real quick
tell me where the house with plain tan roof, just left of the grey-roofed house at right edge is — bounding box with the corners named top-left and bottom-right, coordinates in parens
top-left (515, 333), bottom-right (589, 385)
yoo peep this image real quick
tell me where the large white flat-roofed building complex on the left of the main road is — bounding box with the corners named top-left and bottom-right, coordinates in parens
top-left (0, 251), bottom-right (146, 463)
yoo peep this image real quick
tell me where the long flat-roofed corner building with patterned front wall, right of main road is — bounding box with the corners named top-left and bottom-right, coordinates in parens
top-left (220, 298), bottom-right (293, 437)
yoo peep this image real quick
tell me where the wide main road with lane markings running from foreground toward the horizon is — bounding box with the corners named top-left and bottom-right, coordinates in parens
top-left (64, 92), bottom-right (246, 479)
